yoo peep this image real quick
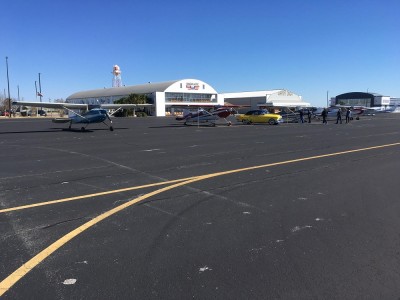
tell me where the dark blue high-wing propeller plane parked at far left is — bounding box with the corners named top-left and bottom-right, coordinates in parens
top-left (13, 101), bottom-right (152, 131)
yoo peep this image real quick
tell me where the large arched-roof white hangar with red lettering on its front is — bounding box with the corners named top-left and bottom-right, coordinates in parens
top-left (66, 79), bottom-right (224, 117)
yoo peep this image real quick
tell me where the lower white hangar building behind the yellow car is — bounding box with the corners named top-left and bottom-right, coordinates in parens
top-left (218, 90), bottom-right (311, 109)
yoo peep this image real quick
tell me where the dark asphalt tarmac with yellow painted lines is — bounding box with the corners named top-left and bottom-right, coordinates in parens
top-left (0, 114), bottom-right (400, 299)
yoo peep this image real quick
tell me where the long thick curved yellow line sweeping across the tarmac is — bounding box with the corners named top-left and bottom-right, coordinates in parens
top-left (0, 143), bottom-right (400, 297)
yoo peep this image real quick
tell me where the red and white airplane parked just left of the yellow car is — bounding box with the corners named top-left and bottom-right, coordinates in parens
top-left (176, 106), bottom-right (234, 126)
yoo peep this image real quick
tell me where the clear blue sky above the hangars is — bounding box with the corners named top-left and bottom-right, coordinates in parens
top-left (0, 0), bottom-right (400, 106)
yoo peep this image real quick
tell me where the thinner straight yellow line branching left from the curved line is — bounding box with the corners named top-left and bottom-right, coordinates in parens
top-left (0, 178), bottom-right (194, 214)
